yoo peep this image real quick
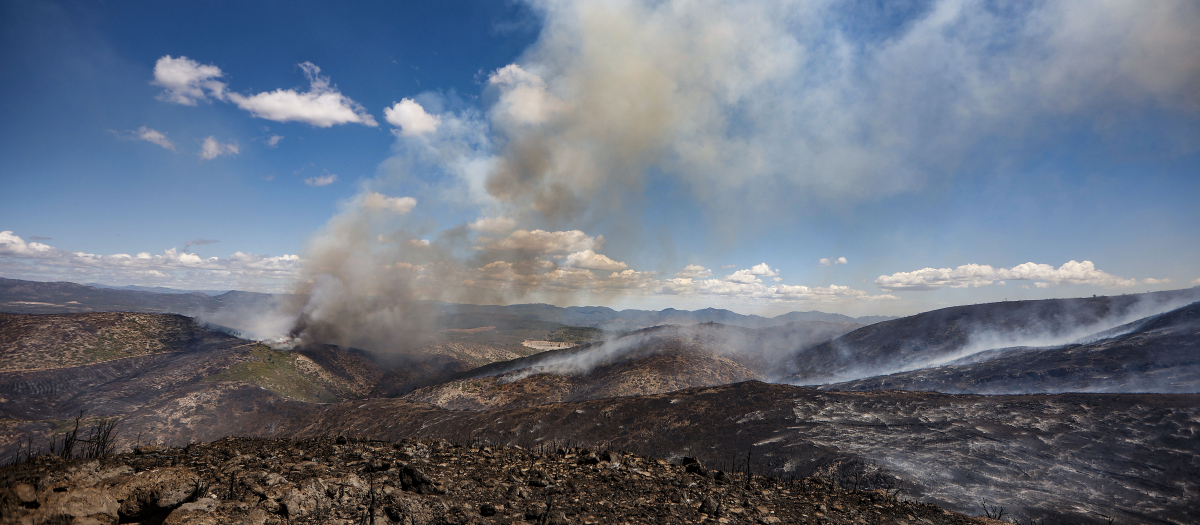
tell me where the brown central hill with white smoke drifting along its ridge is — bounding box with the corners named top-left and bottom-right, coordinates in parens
top-left (406, 321), bottom-right (860, 410)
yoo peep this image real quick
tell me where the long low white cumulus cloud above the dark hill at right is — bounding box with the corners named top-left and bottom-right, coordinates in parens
top-left (875, 260), bottom-right (1160, 291)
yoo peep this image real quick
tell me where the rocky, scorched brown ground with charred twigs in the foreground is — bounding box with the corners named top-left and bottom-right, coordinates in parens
top-left (0, 438), bottom-right (1002, 525)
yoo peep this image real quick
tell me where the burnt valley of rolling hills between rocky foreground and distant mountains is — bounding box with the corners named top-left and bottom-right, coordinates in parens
top-left (0, 282), bottom-right (1200, 524)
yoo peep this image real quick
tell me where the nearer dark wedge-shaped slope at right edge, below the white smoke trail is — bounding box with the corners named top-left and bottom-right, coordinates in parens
top-left (822, 302), bottom-right (1200, 393)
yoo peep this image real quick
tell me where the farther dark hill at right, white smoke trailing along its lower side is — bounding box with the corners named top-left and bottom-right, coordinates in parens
top-left (786, 288), bottom-right (1200, 385)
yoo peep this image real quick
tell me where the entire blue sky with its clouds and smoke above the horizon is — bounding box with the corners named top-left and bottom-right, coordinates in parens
top-left (0, 0), bottom-right (1200, 315)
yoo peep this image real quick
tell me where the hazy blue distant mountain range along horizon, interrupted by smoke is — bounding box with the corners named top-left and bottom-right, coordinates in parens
top-left (0, 278), bottom-right (896, 330)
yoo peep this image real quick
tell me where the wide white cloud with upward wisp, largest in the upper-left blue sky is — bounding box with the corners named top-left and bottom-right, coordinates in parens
top-left (227, 62), bottom-right (378, 127)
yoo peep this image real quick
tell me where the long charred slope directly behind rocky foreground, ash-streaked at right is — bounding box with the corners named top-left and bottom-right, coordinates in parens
top-left (100, 381), bottom-right (1200, 524)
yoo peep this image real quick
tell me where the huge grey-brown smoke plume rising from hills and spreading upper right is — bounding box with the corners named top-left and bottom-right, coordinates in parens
top-left (285, 0), bottom-right (1200, 357)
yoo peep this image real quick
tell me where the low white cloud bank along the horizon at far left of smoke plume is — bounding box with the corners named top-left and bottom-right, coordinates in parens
top-left (0, 231), bottom-right (301, 291)
